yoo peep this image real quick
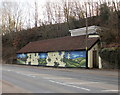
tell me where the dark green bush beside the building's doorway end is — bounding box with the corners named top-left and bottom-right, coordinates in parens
top-left (99, 47), bottom-right (120, 69)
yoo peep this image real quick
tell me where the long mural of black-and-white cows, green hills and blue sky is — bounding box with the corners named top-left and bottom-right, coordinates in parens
top-left (17, 51), bottom-right (86, 67)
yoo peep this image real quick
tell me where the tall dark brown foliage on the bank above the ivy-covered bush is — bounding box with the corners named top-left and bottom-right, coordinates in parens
top-left (98, 2), bottom-right (120, 44)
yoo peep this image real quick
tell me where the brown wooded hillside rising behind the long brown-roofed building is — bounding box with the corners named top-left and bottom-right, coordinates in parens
top-left (2, 16), bottom-right (118, 67)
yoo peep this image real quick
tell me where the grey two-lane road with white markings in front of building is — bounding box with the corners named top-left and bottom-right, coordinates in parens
top-left (2, 65), bottom-right (118, 93)
